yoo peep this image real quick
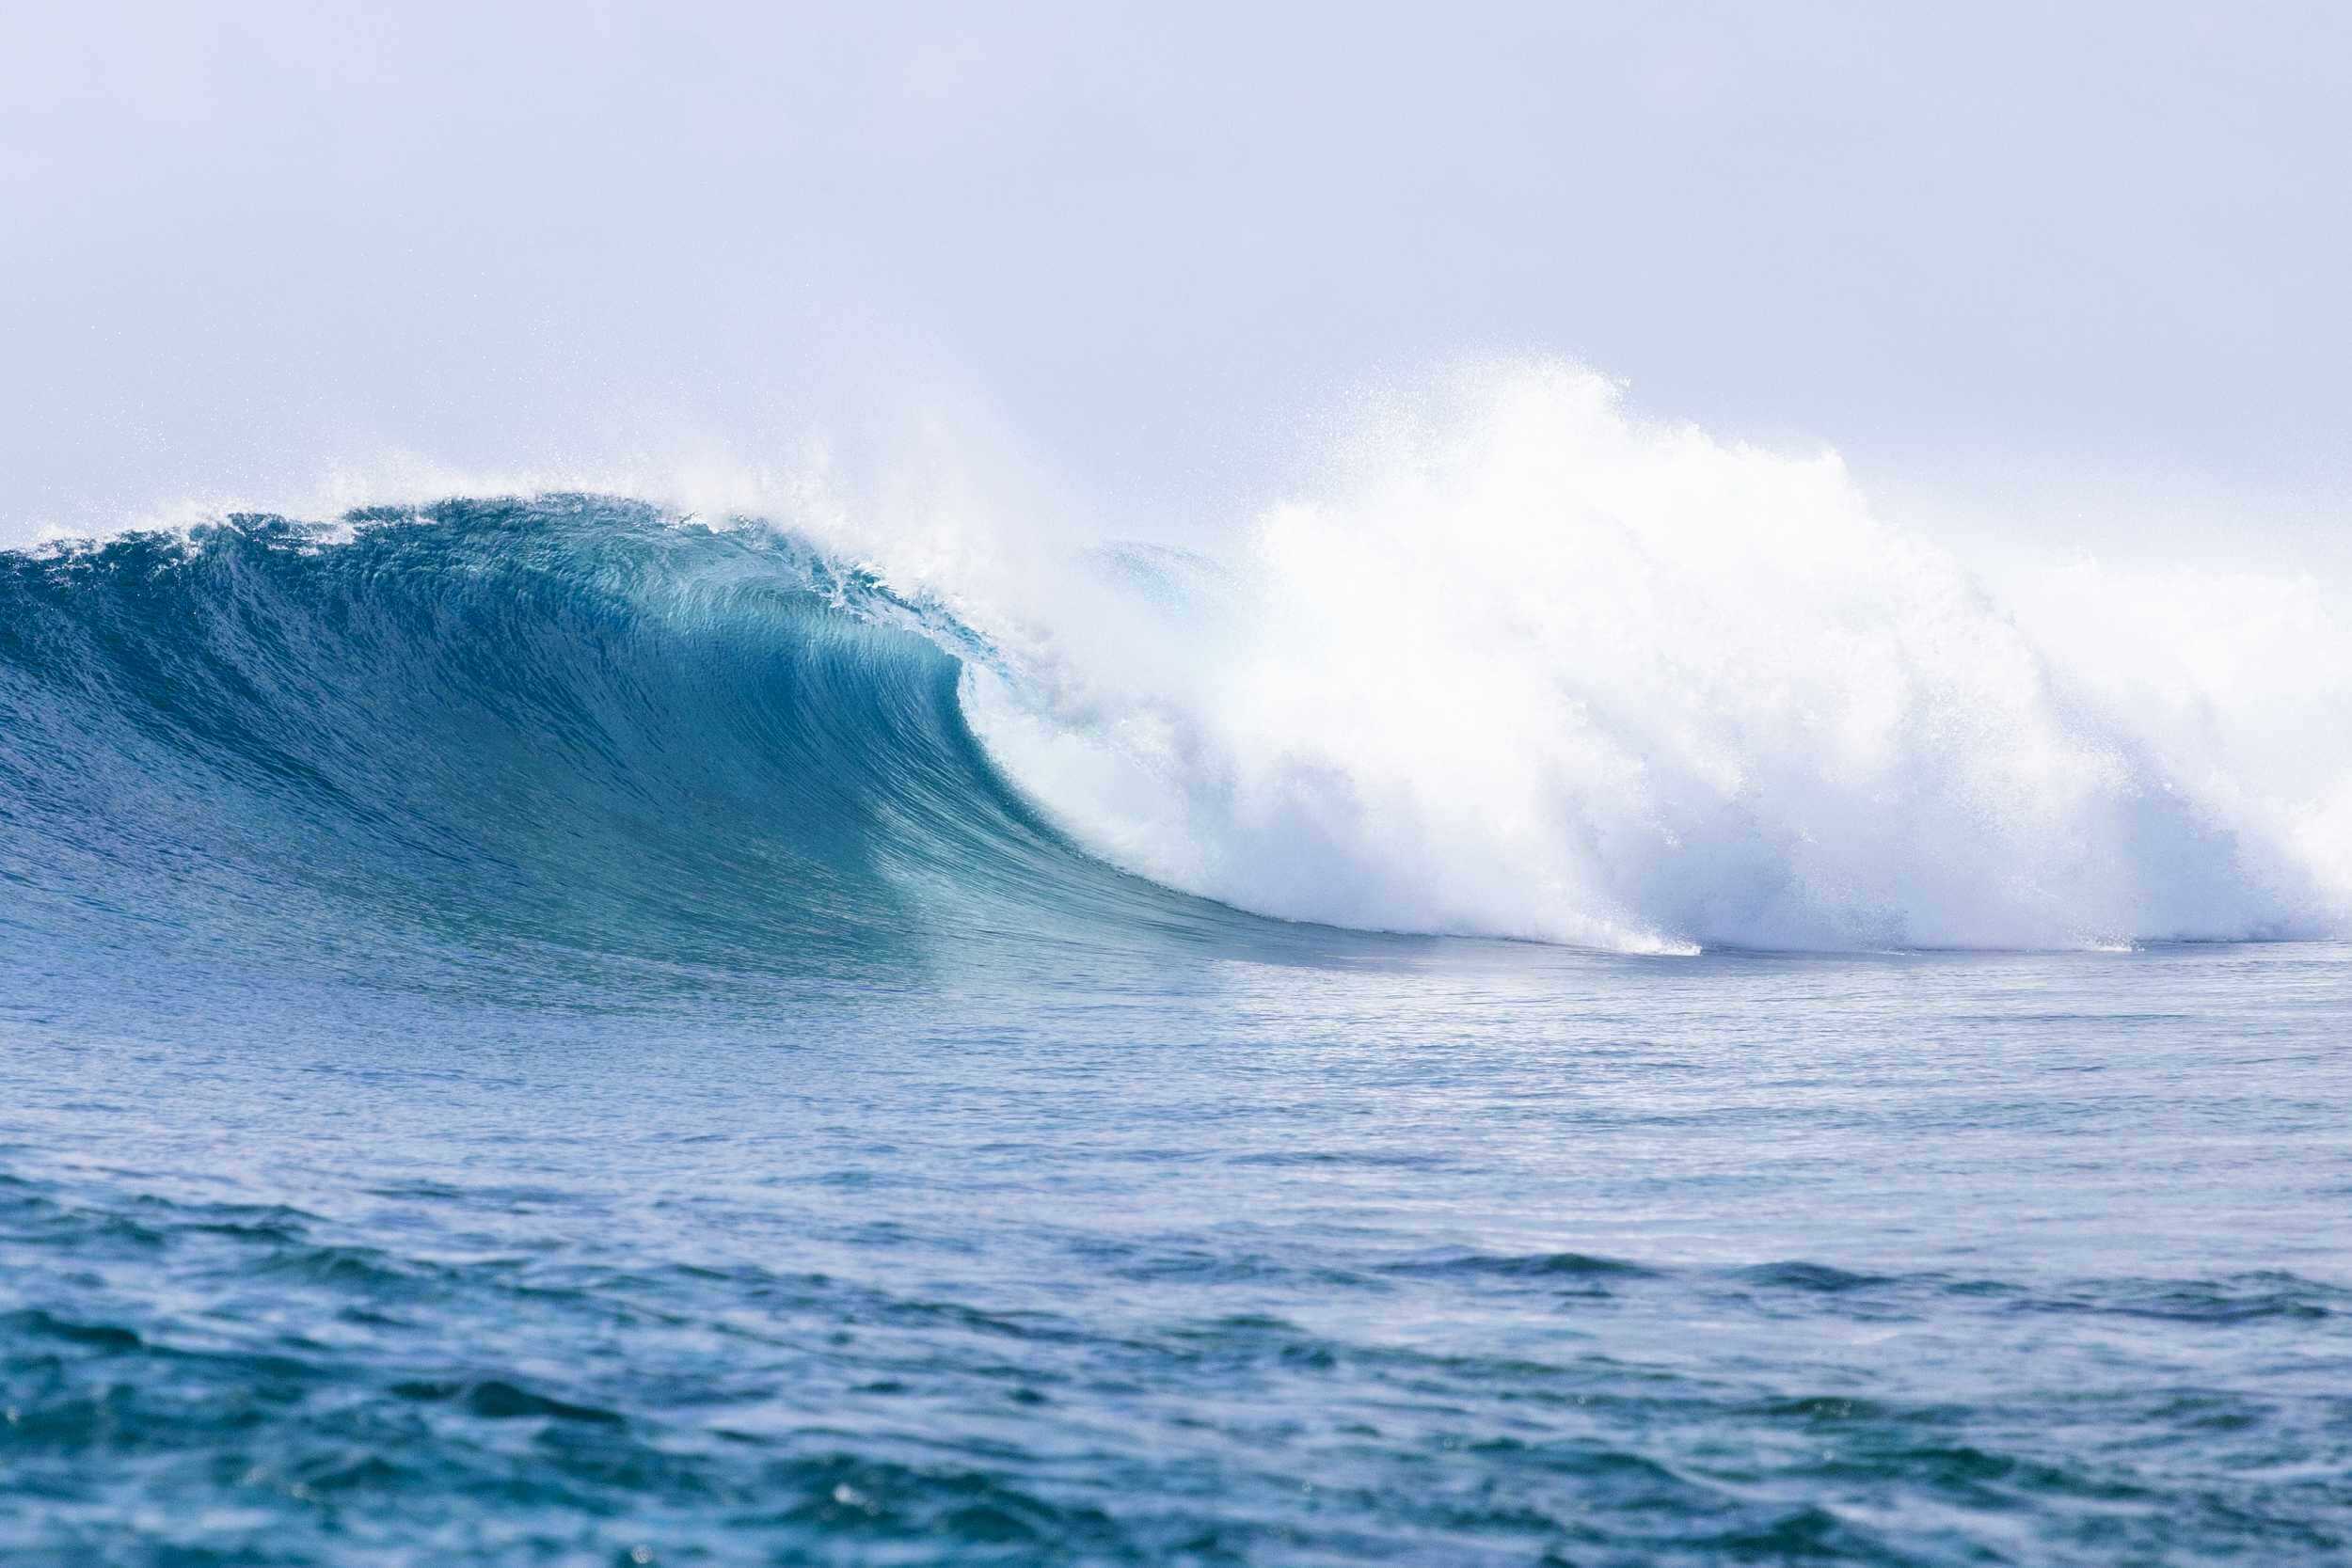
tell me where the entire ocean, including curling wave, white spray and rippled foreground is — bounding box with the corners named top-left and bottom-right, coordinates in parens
top-left (0, 362), bottom-right (2352, 1568)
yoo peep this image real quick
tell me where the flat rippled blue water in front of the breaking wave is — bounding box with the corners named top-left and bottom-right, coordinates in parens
top-left (0, 941), bottom-right (2352, 1563)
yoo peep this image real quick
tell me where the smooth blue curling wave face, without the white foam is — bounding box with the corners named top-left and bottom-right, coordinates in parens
top-left (0, 496), bottom-right (1263, 990)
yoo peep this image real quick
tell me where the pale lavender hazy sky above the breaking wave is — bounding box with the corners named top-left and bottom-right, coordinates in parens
top-left (0, 2), bottom-right (2352, 538)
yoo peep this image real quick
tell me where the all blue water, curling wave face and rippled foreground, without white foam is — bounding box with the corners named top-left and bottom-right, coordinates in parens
top-left (0, 510), bottom-right (2352, 1566)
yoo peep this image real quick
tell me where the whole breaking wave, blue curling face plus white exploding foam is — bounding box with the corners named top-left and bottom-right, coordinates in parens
top-left (0, 367), bottom-right (2352, 975)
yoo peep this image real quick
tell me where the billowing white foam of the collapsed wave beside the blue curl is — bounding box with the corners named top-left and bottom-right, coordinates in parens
top-left (946, 364), bottom-right (2352, 950)
